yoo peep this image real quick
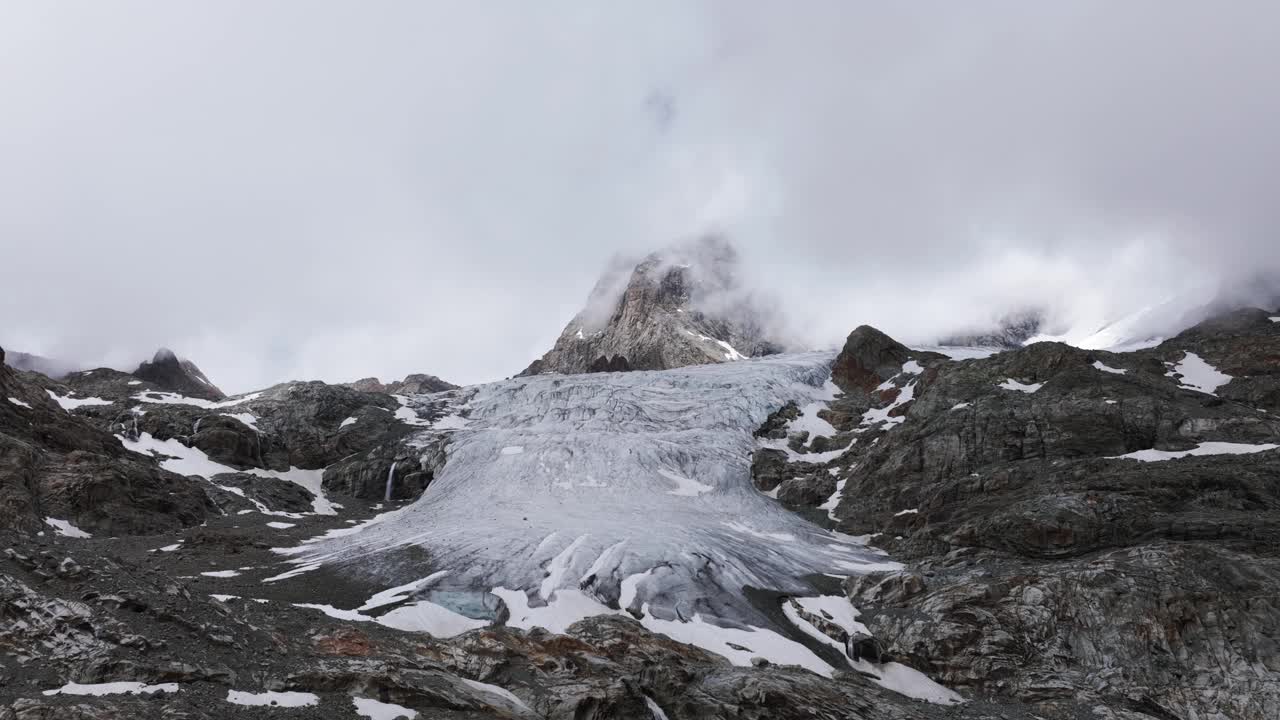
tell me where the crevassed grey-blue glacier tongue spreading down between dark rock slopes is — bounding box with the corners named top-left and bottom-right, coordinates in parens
top-left (297, 354), bottom-right (896, 626)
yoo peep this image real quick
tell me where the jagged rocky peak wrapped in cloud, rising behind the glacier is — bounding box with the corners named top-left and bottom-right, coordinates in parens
top-left (521, 236), bottom-right (783, 375)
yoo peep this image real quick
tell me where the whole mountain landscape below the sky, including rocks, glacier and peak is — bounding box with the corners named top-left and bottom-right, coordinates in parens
top-left (0, 292), bottom-right (1280, 720)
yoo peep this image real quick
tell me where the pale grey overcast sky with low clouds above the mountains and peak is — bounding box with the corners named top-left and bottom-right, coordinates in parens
top-left (0, 0), bottom-right (1280, 392)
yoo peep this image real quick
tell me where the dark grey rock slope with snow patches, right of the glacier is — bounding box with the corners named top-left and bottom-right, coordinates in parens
top-left (753, 310), bottom-right (1280, 720)
